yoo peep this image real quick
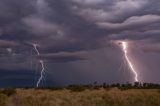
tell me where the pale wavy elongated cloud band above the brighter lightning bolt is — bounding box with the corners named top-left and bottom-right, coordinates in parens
top-left (98, 15), bottom-right (160, 31)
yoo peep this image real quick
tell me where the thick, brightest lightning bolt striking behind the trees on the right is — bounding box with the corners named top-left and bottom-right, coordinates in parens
top-left (121, 41), bottom-right (138, 82)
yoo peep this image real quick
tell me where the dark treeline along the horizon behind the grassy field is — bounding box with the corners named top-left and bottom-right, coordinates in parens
top-left (32, 82), bottom-right (160, 91)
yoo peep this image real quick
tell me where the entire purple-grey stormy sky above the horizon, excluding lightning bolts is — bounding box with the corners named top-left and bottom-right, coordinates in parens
top-left (0, 0), bottom-right (160, 87)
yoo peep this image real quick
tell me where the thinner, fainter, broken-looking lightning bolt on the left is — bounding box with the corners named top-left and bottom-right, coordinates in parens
top-left (32, 44), bottom-right (45, 87)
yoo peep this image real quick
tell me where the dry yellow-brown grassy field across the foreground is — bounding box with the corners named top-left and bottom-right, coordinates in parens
top-left (0, 88), bottom-right (160, 106)
